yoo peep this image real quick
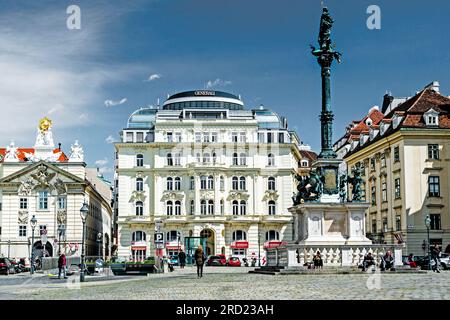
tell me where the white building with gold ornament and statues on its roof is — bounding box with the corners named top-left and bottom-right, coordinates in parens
top-left (0, 118), bottom-right (112, 258)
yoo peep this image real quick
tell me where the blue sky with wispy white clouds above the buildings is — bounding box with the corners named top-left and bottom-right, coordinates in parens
top-left (0, 0), bottom-right (450, 179)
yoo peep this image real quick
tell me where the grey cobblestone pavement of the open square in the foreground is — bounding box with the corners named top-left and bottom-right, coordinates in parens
top-left (0, 267), bottom-right (450, 300)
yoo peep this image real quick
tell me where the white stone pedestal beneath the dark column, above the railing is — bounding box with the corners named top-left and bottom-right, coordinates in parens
top-left (289, 202), bottom-right (372, 245)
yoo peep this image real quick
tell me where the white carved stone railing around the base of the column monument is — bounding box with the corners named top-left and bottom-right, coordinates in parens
top-left (265, 244), bottom-right (403, 267)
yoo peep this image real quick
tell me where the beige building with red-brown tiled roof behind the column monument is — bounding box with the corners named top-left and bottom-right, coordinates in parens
top-left (335, 82), bottom-right (450, 255)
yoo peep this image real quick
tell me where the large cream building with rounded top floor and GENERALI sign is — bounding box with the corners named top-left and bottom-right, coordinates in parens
top-left (115, 90), bottom-right (301, 260)
